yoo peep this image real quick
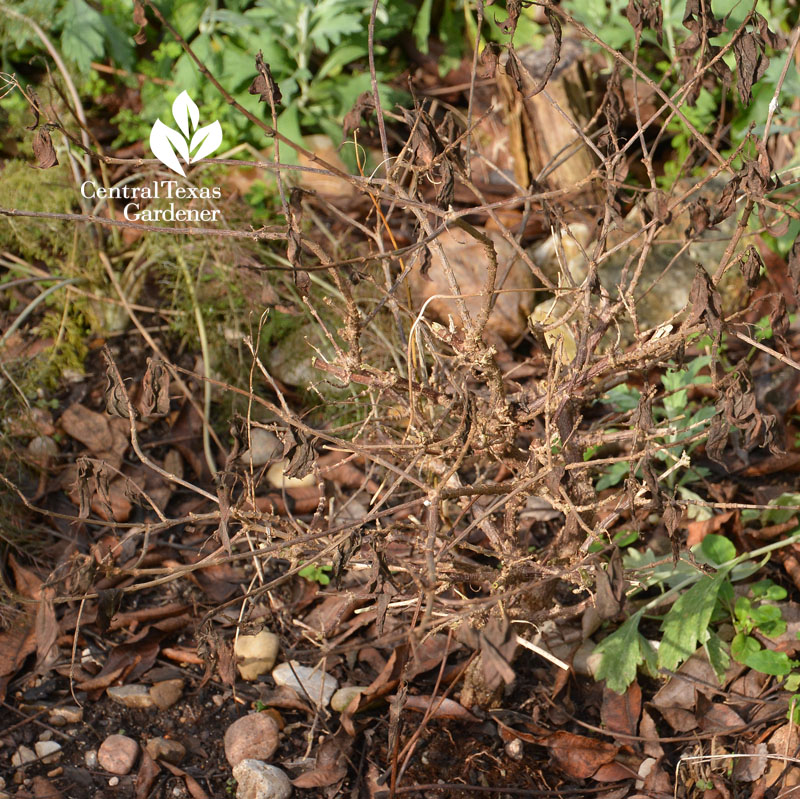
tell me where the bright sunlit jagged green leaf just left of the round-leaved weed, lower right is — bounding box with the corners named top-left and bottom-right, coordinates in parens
top-left (658, 571), bottom-right (728, 671)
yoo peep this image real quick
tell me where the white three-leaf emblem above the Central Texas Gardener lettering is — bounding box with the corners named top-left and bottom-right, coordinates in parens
top-left (150, 91), bottom-right (222, 177)
